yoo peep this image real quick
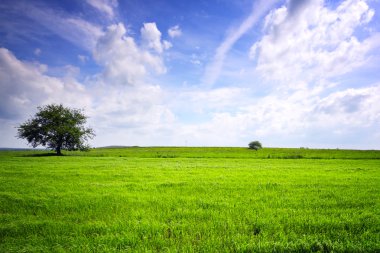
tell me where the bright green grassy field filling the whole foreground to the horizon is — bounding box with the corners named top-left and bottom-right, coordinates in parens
top-left (0, 147), bottom-right (380, 252)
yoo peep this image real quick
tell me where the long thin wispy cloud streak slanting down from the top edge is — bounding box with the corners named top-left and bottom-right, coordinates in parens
top-left (203, 0), bottom-right (278, 85)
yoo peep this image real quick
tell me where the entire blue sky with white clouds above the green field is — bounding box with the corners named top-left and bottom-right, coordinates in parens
top-left (0, 0), bottom-right (380, 149)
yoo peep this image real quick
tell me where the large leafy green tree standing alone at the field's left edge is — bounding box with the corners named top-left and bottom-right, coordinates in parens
top-left (17, 104), bottom-right (95, 155)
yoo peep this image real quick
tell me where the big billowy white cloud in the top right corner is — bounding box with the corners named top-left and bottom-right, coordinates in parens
top-left (250, 0), bottom-right (380, 85)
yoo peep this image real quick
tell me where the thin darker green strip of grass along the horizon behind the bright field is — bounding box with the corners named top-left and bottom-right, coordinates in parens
top-left (7, 147), bottom-right (380, 159)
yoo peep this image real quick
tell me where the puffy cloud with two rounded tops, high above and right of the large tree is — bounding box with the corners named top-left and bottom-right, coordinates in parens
top-left (93, 23), bottom-right (166, 85)
